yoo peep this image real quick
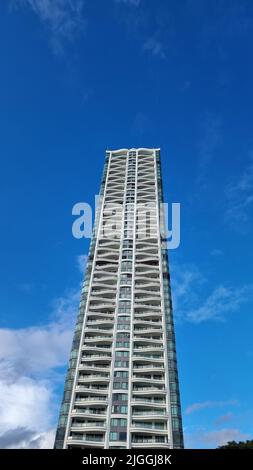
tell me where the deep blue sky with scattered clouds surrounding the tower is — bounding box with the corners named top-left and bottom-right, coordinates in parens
top-left (0, 0), bottom-right (253, 448)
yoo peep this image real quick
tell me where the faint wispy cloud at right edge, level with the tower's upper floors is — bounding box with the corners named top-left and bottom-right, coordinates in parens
top-left (225, 152), bottom-right (253, 232)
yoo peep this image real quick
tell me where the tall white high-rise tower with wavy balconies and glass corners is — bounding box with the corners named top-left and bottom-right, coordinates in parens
top-left (55, 148), bottom-right (183, 449)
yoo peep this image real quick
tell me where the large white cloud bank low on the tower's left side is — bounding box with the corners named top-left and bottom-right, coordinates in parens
top-left (0, 282), bottom-right (80, 448)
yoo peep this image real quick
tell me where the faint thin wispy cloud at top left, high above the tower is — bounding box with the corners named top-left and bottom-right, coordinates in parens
top-left (10, 0), bottom-right (85, 56)
